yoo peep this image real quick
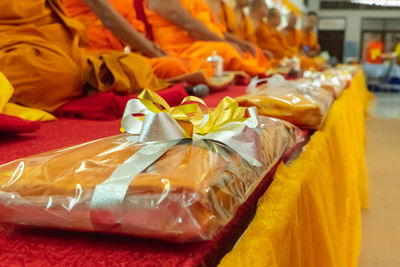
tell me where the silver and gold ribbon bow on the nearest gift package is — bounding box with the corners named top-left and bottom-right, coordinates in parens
top-left (91, 89), bottom-right (261, 211)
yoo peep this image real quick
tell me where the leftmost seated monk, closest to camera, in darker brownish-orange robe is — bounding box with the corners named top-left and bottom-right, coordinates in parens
top-left (0, 0), bottom-right (167, 112)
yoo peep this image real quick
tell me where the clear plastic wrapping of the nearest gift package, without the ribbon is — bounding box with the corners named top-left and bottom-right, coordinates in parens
top-left (0, 116), bottom-right (298, 242)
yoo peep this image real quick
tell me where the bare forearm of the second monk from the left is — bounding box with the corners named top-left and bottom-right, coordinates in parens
top-left (84, 0), bottom-right (166, 57)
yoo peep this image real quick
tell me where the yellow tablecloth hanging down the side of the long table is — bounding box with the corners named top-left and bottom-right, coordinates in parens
top-left (220, 71), bottom-right (368, 267)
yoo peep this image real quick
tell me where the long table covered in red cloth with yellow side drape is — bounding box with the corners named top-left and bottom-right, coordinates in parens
top-left (0, 72), bottom-right (367, 267)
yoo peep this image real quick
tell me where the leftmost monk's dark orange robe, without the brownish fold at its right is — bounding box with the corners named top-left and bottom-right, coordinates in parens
top-left (0, 0), bottom-right (83, 111)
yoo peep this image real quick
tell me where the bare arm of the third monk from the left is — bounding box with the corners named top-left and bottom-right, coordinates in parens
top-left (148, 0), bottom-right (224, 42)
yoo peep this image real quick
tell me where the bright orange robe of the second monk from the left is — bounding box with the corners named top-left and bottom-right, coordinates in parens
top-left (63, 0), bottom-right (215, 79)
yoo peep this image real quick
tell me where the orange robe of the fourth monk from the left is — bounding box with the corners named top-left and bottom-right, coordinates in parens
top-left (219, 1), bottom-right (257, 44)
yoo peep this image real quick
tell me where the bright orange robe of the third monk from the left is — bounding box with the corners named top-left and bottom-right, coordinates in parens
top-left (145, 0), bottom-right (269, 76)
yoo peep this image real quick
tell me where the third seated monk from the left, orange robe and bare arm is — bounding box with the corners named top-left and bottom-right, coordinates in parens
top-left (144, 0), bottom-right (269, 76)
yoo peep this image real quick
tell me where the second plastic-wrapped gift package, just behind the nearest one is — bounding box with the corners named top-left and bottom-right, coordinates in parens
top-left (236, 75), bottom-right (334, 129)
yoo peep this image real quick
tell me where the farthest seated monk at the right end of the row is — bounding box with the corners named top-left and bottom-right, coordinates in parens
top-left (301, 11), bottom-right (321, 57)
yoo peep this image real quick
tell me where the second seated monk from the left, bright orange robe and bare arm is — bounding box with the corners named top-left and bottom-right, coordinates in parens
top-left (63, 0), bottom-right (219, 79)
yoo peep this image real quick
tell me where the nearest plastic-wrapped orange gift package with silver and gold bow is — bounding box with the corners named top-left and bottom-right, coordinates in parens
top-left (0, 91), bottom-right (299, 242)
